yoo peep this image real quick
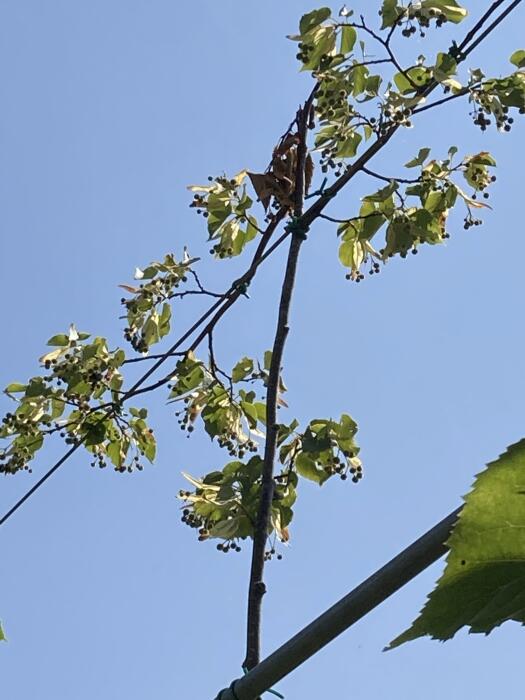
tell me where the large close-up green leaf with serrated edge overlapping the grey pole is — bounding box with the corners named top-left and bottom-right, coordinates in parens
top-left (388, 440), bottom-right (525, 648)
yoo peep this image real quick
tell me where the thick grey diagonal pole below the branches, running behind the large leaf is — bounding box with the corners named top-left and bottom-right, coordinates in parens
top-left (215, 508), bottom-right (461, 700)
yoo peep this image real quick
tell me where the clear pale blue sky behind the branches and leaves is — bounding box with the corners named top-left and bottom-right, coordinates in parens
top-left (0, 0), bottom-right (525, 700)
